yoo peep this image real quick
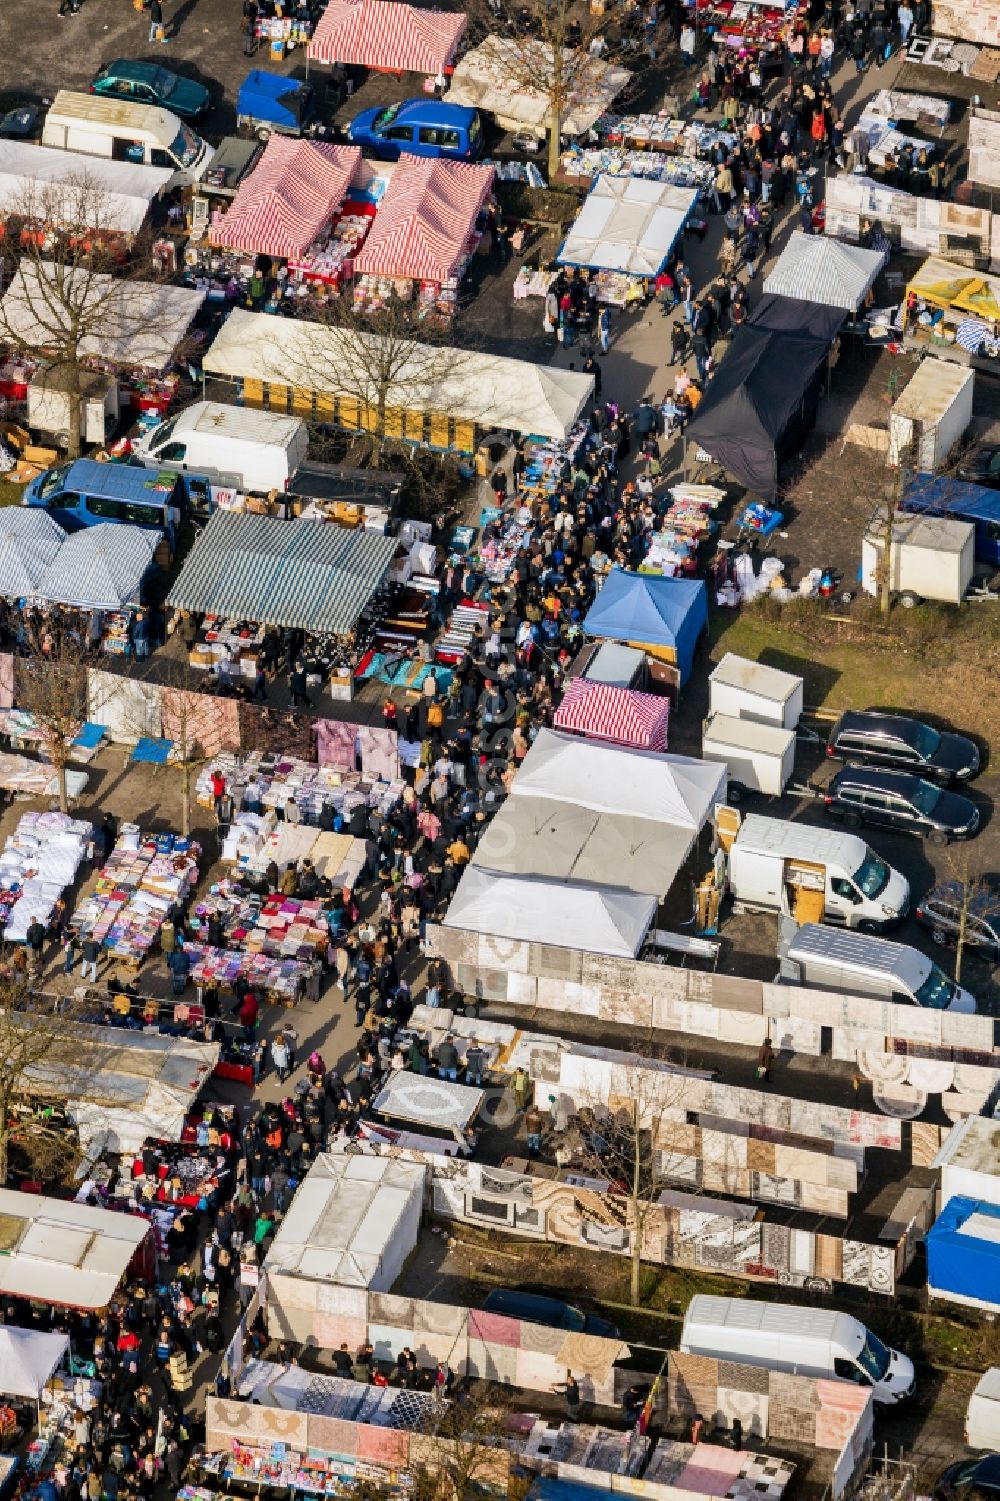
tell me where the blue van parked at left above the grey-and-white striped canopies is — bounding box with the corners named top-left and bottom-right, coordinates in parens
top-left (24, 459), bottom-right (186, 552)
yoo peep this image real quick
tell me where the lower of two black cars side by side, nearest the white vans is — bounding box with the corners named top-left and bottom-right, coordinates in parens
top-left (823, 766), bottom-right (979, 844)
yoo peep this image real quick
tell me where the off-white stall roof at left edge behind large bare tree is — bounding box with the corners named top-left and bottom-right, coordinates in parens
top-left (0, 260), bottom-right (207, 371)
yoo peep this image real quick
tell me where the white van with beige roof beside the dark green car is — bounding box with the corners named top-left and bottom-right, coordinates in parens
top-left (42, 89), bottom-right (212, 188)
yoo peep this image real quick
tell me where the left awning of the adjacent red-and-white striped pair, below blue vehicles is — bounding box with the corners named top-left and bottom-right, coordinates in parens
top-left (209, 135), bottom-right (362, 258)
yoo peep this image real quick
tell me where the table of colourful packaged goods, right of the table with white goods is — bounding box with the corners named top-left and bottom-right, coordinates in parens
top-left (69, 824), bottom-right (201, 970)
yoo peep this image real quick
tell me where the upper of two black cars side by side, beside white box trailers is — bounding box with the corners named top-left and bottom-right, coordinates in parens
top-left (826, 708), bottom-right (979, 782)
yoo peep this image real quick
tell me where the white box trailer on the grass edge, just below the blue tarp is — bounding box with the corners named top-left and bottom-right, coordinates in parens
top-left (862, 506), bottom-right (976, 606)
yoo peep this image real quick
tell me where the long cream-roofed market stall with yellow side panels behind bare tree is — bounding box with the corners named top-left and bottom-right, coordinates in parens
top-left (201, 308), bottom-right (593, 444)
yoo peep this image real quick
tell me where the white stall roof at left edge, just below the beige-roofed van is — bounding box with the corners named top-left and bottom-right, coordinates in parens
top-left (0, 140), bottom-right (173, 234)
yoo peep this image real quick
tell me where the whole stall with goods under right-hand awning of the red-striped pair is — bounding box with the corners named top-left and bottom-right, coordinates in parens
top-left (354, 155), bottom-right (494, 317)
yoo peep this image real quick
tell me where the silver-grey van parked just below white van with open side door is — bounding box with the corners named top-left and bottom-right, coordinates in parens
top-left (781, 923), bottom-right (976, 1015)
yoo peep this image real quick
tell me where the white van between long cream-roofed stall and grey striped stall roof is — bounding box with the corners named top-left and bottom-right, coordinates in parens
top-left (134, 401), bottom-right (309, 495)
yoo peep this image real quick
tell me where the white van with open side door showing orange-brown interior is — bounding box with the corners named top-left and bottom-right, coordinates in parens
top-left (728, 814), bottom-right (910, 934)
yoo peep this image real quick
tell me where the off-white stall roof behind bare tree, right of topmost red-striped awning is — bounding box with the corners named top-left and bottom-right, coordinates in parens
top-left (447, 36), bottom-right (632, 137)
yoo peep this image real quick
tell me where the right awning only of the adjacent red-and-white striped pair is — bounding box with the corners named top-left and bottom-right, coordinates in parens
top-left (354, 155), bottom-right (492, 282)
